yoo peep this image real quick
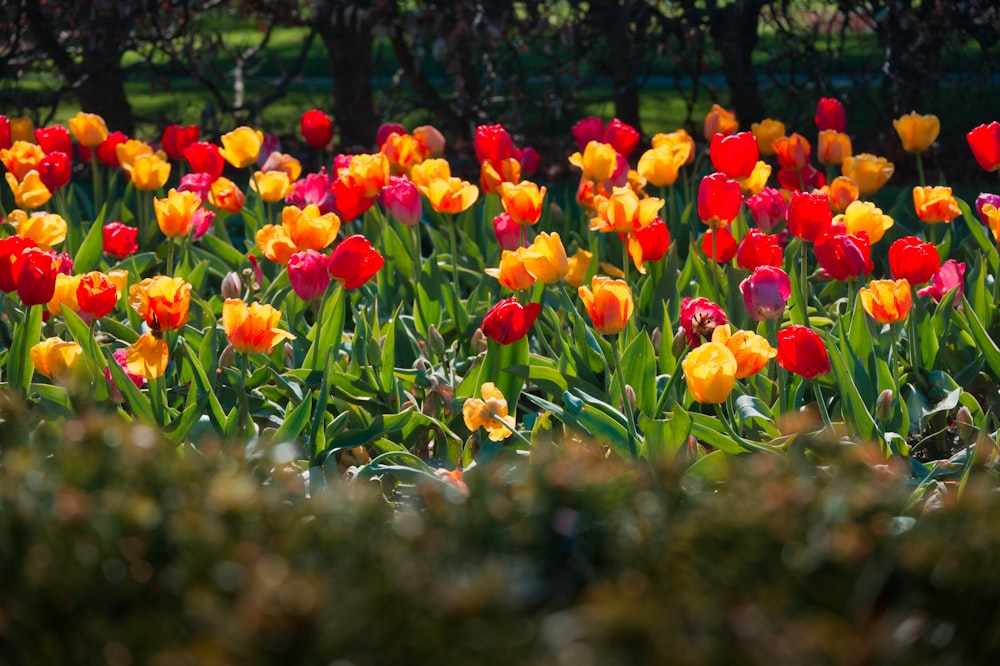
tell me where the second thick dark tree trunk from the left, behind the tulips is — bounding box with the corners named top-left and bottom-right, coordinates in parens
top-left (316, 2), bottom-right (379, 150)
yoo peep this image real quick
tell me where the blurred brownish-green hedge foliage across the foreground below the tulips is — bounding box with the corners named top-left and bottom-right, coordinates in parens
top-left (0, 398), bottom-right (1000, 665)
